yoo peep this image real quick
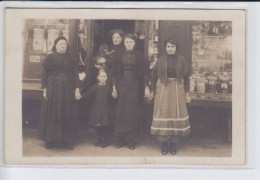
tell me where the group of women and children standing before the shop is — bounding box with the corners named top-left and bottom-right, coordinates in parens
top-left (39, 29), bottom-right (191, 155)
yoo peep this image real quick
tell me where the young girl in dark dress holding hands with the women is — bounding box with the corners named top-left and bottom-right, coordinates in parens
top-left (82, 70), bottom-right (113, 148)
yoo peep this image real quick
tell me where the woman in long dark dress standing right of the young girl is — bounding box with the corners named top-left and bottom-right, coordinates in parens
top-left (112, 34), bottom-right (150, 149)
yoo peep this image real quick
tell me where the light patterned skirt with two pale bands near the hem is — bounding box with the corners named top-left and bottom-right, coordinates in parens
top-left (151, 78), bottom-right (190, 141)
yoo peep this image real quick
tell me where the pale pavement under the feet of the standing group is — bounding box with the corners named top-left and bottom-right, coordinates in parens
top-left (23, 128), bottom-right (232, 157)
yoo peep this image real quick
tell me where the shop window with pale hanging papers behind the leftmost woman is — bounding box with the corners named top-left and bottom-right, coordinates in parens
top-left (23, 19), bottom-right (70, 81)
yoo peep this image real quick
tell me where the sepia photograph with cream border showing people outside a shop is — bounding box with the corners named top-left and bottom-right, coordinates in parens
top-left (5, 9), bottom-right (246, 166)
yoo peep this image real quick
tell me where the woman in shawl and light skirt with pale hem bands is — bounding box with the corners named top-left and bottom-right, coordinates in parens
top-left (151, 39), bottom-right (191, 155)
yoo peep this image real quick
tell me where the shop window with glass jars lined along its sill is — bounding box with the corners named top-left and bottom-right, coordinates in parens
top-left (190, 21), bottom-right (232, 94)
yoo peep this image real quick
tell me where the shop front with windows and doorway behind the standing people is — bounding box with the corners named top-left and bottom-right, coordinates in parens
top-left (23, 19), bottom-right (232, 140)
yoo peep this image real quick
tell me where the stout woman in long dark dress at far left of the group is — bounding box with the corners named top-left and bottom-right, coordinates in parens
top-left (39, 37), bottom-right (80, 149)
